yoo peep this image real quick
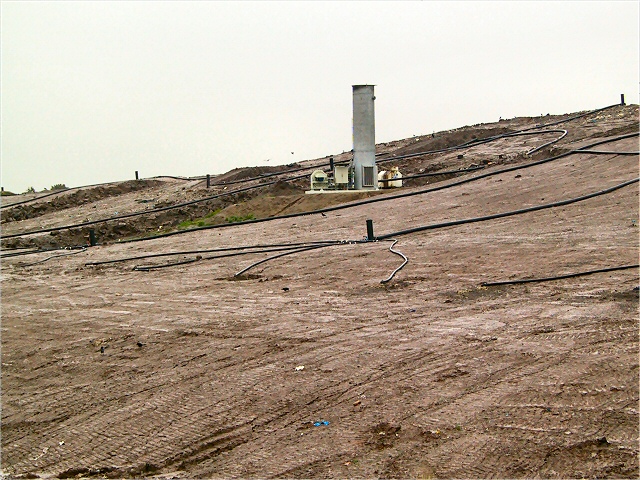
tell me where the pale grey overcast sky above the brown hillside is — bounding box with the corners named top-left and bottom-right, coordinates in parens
top-left (1, 1), bottom-right (640, 193)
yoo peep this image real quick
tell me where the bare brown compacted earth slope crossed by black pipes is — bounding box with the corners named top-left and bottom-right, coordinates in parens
top-left (0, 105), bottom-right (640, 479)
